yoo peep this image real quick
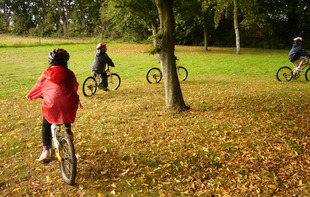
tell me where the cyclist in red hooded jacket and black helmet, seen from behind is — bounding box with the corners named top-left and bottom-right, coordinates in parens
top-left (27, 49), bottom-right (82, 163)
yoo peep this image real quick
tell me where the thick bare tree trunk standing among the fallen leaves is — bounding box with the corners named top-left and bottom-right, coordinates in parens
top-left (155, 0), bottom-right (186, 110)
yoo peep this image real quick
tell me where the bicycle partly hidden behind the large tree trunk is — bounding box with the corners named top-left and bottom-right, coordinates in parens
top-left (146, 58), bottom-right (188, 84)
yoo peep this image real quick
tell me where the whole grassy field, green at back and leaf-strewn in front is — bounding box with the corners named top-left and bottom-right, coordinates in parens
top-left (0, 36), bottom-right (310, 196)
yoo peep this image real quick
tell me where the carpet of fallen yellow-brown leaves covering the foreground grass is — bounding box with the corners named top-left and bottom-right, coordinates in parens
top-left (0, 76), bottom-right (310, 196)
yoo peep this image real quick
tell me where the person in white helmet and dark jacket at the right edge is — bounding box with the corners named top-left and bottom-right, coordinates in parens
top-left (289, 37), bottom-right (310, 74)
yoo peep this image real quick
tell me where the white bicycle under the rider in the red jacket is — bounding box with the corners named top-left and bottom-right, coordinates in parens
top-left (51, 124), bottom-right (77, 185)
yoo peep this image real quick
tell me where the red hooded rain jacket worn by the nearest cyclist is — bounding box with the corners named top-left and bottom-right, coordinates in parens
top-left (27, 66), bottom-right (80, 124)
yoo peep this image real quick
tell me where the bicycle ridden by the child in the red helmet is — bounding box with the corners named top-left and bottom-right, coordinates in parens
top-left (82, 66), bottom-right (121, 97)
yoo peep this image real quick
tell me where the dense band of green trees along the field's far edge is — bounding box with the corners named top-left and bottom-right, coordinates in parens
top-left (0, 0), bottom-right (310, 48)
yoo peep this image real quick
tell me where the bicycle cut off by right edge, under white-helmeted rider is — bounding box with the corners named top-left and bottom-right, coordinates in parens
top-left (277, 58), bottom-right (310, 81)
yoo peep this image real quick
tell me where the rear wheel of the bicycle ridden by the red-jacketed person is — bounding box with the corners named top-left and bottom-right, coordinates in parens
top-left (59, 134), bottom-right (77, 185)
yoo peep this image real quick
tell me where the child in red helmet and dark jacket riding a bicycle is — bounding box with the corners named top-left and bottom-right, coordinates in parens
top-left (91, 42), bottom-right (114, 91)
